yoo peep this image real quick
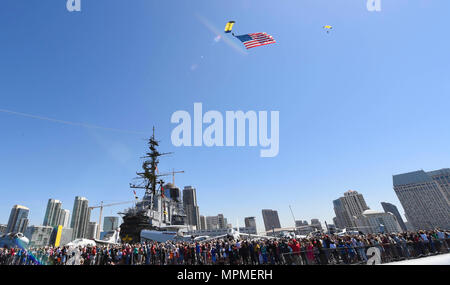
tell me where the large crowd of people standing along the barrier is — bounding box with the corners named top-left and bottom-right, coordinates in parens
top-left (0, 229), bottom-right (450, 265)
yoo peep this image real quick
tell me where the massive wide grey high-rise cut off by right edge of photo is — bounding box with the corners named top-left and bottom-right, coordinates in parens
top-left (392, 169), bottom-right (450, 230)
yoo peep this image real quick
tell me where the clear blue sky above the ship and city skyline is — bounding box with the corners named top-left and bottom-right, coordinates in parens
top-left (0, 0), bottom-right (450, 232)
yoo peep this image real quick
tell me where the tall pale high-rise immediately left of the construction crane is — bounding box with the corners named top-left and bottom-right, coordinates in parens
top-left (70, 196), bottom-right (91, 239)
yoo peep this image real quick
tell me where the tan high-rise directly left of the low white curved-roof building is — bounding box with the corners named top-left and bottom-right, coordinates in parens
top-left (333, 190), bottom-right (369, 228)
